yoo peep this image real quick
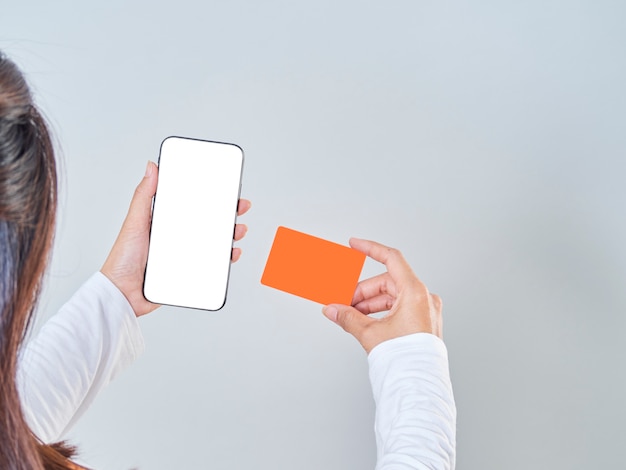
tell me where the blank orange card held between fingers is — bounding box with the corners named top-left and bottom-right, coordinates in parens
top-left (261, 227), bottom-right (365, 305)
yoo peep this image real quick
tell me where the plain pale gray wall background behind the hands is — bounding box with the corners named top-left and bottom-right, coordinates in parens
top-left (0, 0), bottom-right (626, 470)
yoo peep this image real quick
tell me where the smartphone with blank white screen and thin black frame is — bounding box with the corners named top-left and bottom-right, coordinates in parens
top-left (143, 137), bottom-right (244, 311)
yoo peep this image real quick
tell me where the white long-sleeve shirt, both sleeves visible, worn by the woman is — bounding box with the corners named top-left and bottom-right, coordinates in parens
top-left (18, 273), bottom-right (456, 470)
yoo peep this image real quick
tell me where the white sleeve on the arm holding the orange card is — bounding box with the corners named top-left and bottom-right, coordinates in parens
top-left (368, 333), bottom-right (456, 470)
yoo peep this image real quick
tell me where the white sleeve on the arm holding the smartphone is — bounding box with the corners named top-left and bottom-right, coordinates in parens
top-left (18, 272), bottom-right (144, 443)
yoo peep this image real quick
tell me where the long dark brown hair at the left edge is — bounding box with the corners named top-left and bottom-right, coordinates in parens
top-left (0, 51), bottom-right (80, 470)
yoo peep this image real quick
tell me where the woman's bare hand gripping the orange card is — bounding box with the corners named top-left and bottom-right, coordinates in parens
top-left (322, 238), bottom-right (442, 354)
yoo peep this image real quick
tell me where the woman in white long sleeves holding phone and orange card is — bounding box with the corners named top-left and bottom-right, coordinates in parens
top-left (0, 53), bottom-right (456, 470)
